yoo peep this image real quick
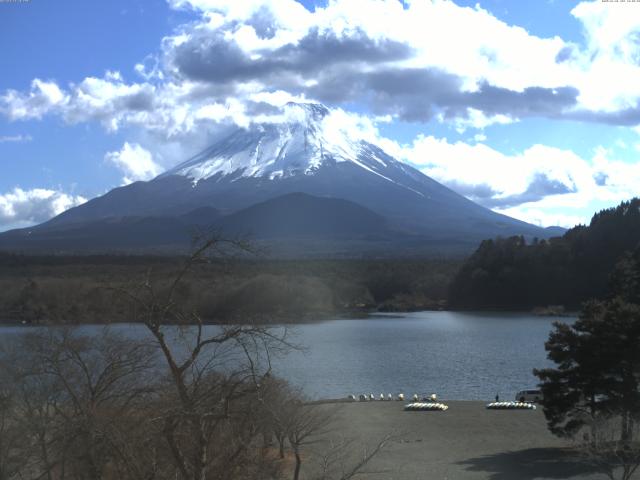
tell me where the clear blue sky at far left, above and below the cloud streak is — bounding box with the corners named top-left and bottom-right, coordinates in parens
top-left (0, 0), bottom-right (194, 197)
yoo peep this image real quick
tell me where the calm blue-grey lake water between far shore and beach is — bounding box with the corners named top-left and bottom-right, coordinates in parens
top-left (0, 312), bottom-right (572, 400)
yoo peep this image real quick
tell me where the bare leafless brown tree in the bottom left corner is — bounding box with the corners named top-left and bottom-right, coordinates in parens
top-left (3, 329), bottom-right (154, 480)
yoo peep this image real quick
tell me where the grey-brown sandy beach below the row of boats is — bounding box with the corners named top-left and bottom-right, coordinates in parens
top-left (308, 401), bottom-right (606, 480)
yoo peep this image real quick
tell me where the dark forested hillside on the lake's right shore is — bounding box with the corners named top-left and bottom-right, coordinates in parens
top-left (449, 198), bottom-right (640, 310)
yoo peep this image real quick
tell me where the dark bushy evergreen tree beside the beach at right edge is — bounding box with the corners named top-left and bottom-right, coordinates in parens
top-left (534, 298), bottom-right (640, 441)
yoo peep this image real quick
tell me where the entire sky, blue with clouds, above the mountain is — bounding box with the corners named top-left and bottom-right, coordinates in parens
top-left (0, 0), bottom-right (640, 230)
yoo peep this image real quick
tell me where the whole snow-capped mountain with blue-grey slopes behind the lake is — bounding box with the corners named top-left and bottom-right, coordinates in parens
top-left (0, 103), bottom-right (558, 256)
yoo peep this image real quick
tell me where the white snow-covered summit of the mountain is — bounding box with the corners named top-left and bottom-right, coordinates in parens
top-left (163, 102), bottom-right (396, 183)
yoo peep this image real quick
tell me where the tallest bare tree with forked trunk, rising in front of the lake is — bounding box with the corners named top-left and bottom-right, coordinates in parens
top-left (115, 238), bottom-right (290, 480)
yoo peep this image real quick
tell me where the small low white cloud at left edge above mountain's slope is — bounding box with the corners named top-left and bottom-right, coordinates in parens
top-left (0, 187), bottom-right (87, 230)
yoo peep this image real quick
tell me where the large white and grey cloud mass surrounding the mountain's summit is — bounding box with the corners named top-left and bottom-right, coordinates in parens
top-left (0, 0), bottom-right (640, 230)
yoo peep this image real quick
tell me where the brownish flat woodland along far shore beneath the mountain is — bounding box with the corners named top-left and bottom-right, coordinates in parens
top-left (0, 254), bottom-right (459, 324)
